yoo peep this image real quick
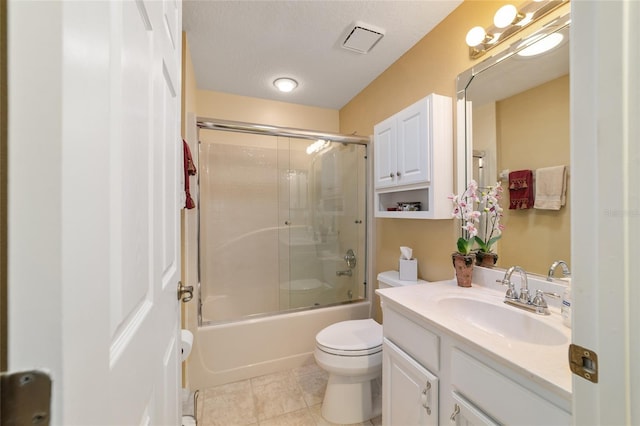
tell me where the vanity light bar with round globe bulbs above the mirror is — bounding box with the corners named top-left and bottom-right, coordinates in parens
top-left (465, 0), bottom-right (569, 59)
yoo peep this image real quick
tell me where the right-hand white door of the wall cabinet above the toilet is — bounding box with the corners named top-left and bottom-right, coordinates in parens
top-left (396, 98), bottom-right (431, 185)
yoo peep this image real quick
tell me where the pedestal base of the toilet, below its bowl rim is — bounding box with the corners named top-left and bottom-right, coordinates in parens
top-left (322, 374), bottom-right (382, 424)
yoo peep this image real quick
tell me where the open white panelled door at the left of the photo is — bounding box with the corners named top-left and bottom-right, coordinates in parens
top-left (8, 0), bottom-right (182, 425)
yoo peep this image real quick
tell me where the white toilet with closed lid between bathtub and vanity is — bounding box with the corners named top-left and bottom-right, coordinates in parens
top-left (314, 271), bottom-right (425, 424)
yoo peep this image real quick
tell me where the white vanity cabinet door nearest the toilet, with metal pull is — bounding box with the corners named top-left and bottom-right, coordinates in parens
top-left (382, 338), bottom-right (438, 426)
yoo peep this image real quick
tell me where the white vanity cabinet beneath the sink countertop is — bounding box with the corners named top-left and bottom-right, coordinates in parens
top-left (381, 293), bottom-right (571, 426)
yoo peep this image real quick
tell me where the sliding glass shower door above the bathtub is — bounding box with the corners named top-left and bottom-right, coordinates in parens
top-left (199, 131), bottom-right (366, 322)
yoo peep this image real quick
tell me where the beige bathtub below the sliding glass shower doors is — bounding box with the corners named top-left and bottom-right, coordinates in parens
top-left (186, 301), bottom-right (371, 390)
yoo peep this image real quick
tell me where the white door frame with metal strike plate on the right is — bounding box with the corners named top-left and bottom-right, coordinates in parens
top-left (570, 0), bottom-right (640, 425)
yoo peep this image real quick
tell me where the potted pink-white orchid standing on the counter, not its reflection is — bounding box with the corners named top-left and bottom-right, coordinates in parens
top-left (449, 180), bottom-right (480, 287)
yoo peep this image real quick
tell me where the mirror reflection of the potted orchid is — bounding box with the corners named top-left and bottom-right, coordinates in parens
top-left (474, 182), bottom-right (504, 267)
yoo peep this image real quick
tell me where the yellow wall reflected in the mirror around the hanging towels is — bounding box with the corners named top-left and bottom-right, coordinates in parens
top-left (496, 75), bottom-right (571, 274)
